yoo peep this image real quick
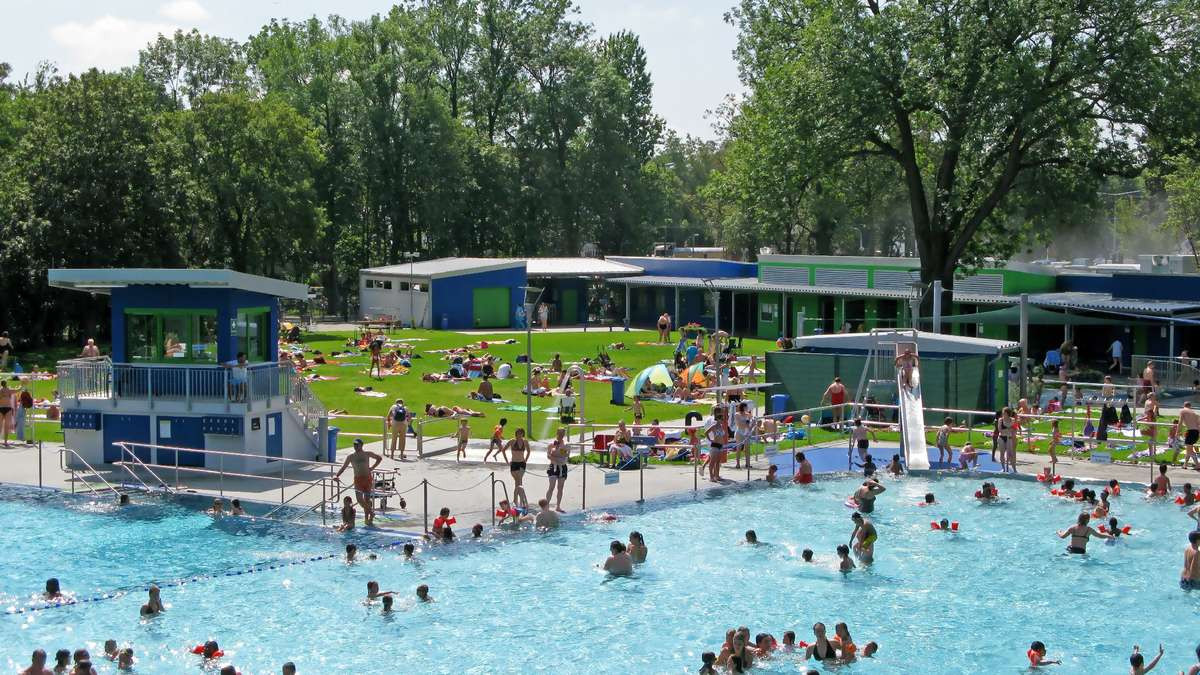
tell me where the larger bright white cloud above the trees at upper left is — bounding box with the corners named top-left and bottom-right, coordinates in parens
top-left (50, 16), bottom-right (176, 72)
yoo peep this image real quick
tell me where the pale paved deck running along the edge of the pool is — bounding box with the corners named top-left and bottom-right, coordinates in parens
top-left (0, 429), bottom-right (1185, 533)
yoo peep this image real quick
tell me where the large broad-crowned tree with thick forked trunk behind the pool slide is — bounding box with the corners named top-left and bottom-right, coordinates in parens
top-left (731, 0), bottom-right (1198, 302)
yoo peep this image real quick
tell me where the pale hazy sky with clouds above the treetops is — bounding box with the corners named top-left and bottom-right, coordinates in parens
top-left (0, 0), bottom-right (743, 138)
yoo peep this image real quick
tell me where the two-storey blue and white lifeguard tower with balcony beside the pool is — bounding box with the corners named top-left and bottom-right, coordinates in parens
top-left (48, 269), bottom-right (328, 473)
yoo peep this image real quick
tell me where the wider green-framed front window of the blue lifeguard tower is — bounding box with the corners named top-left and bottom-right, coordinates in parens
top-left (125, 307), bottom-right (217, 364)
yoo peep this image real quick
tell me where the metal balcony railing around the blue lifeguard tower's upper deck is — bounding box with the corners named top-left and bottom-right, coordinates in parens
top-left (58, 357), bottom-right (291, 410)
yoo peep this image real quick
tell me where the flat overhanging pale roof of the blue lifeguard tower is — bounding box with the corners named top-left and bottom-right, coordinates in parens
top-left (47, 268), bottom-right (308, 300)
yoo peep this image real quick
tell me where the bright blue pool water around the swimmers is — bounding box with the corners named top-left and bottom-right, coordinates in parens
top-left (0, 477), bottom-right (1200, 674)
